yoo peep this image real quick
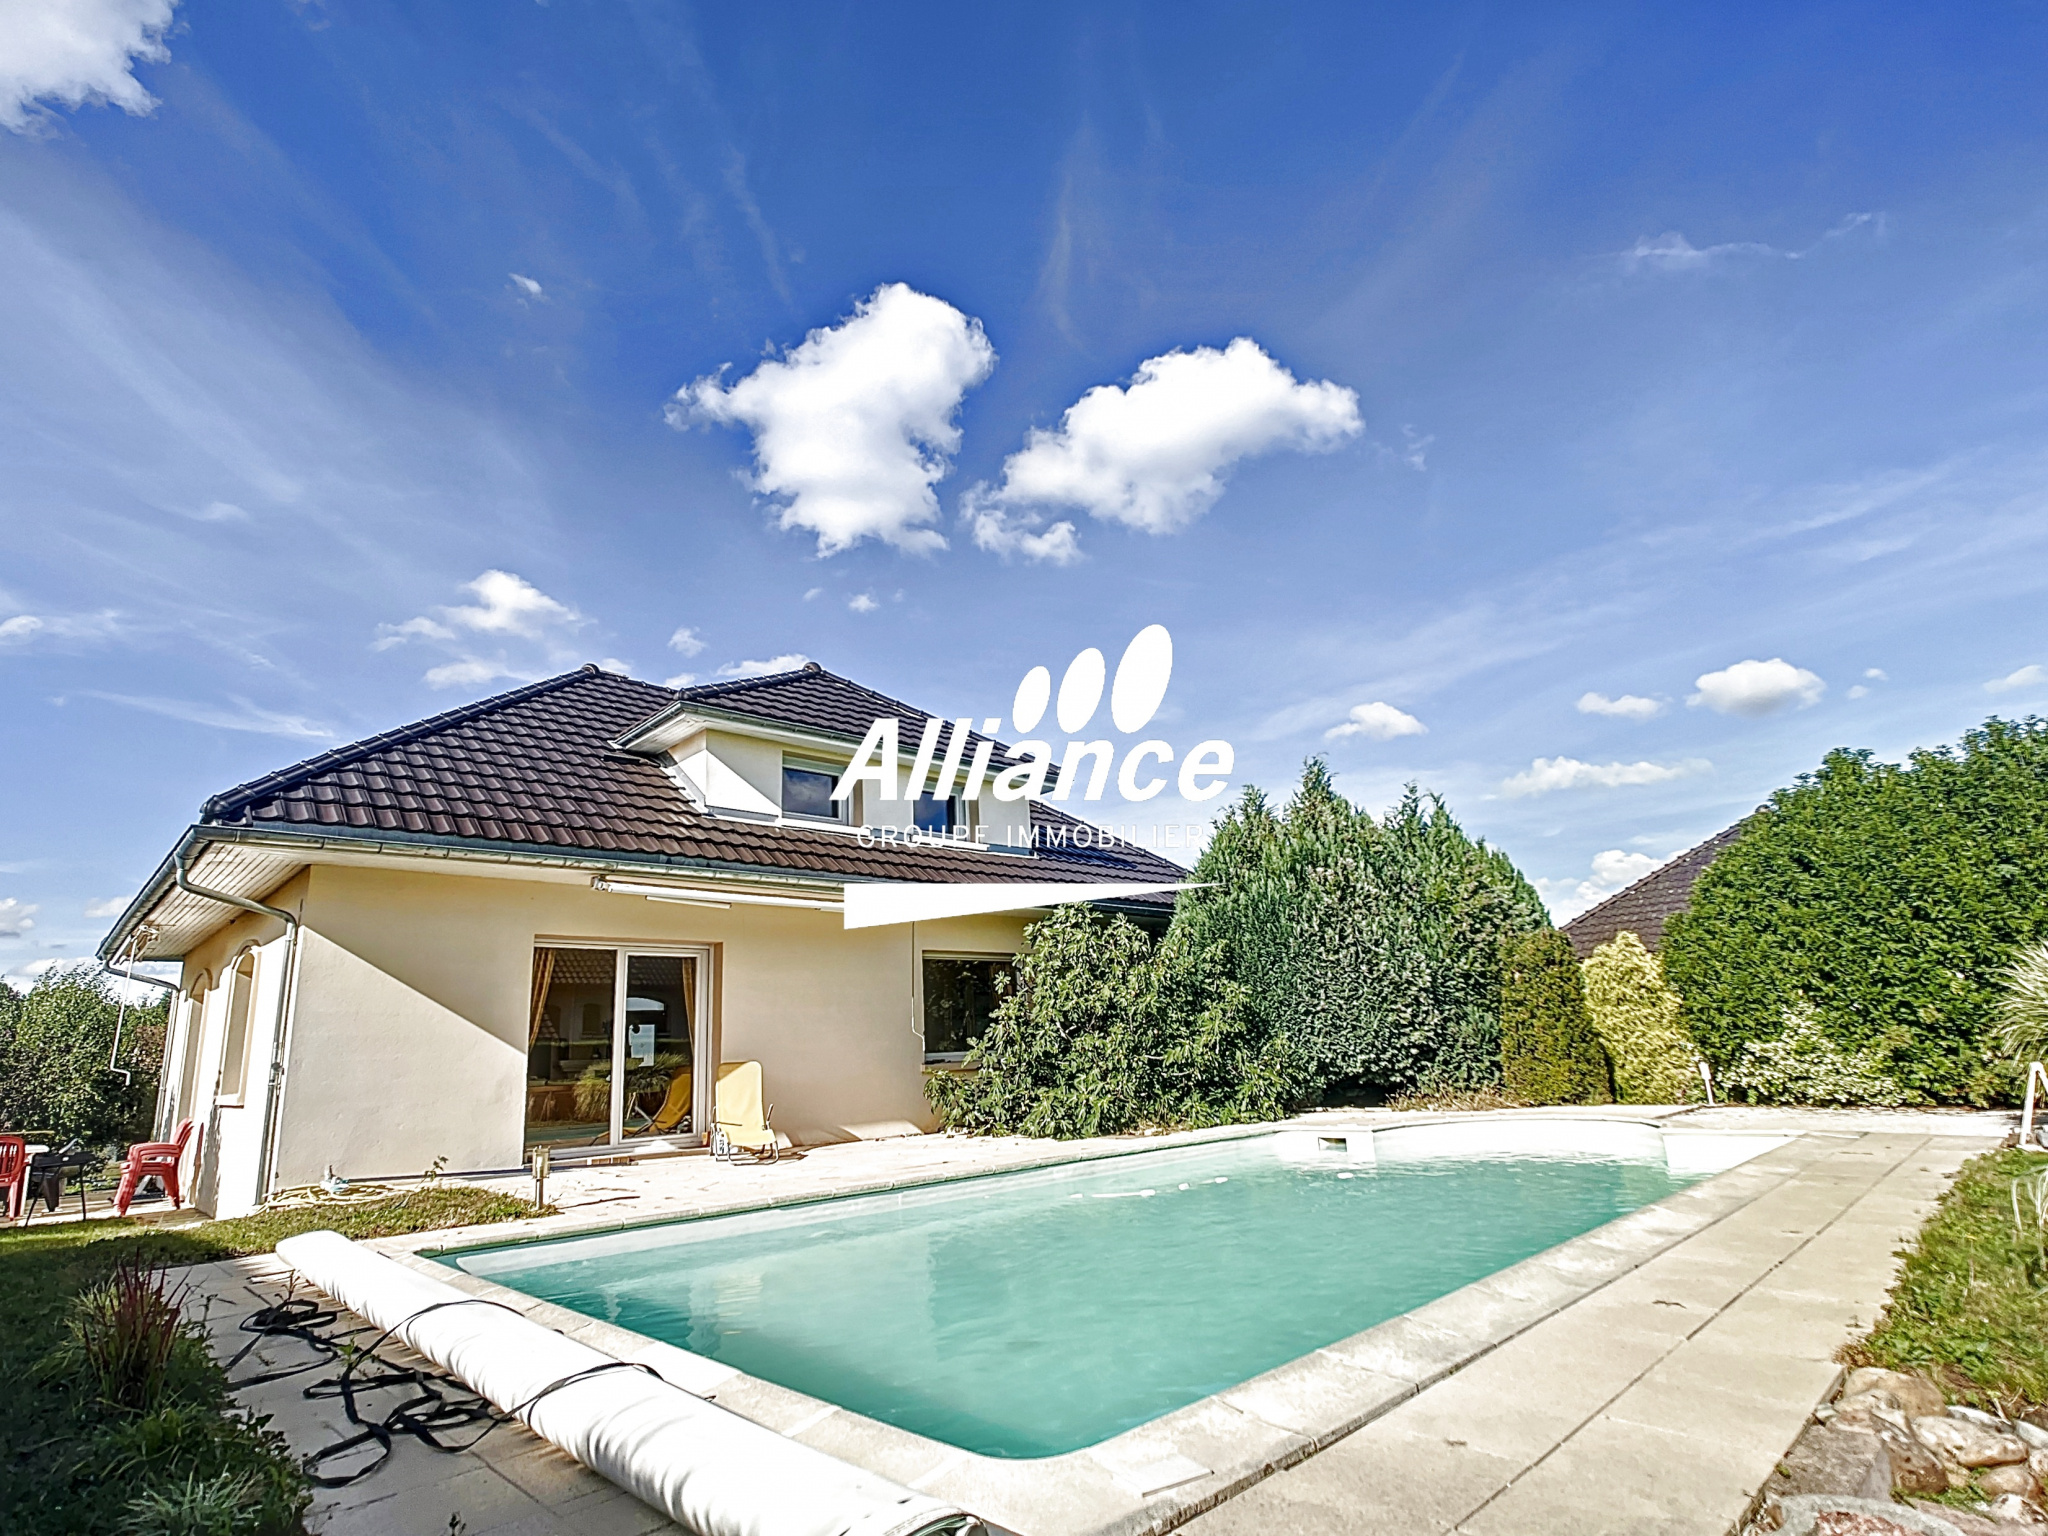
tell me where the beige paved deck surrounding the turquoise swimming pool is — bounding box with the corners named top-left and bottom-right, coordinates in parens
top-left (184, 1108), bottom-right (2011, 1536)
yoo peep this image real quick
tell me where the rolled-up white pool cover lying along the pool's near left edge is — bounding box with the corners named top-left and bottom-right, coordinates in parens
top-left (276, 1233), bottom-right (983, 1536)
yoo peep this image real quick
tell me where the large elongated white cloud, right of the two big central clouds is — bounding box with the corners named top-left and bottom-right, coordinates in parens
top-left (963, 336), bottom-right (1364, 563)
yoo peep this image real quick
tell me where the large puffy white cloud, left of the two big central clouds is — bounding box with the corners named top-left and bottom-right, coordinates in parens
top-left (668, 283), bottom-right (995, 555)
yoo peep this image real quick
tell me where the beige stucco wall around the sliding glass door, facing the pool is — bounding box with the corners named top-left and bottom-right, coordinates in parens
top-left (251, 866), bottom-right (1026, 1188)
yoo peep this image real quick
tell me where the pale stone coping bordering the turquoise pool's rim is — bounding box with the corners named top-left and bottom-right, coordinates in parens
top-left (356, 1112), bottom-right (1839, 1536)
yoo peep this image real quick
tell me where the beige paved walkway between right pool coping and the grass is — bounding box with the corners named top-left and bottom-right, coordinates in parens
top-left (1188, 1118), bottom-right (1993, 1536)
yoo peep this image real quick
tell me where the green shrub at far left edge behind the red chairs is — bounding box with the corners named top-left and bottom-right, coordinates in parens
top-left (0, 965), bottom-right (168, 1147)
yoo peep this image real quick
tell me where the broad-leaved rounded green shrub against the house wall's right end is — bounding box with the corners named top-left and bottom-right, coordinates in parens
top-left (926, 905), bottom-right (1303, 1137)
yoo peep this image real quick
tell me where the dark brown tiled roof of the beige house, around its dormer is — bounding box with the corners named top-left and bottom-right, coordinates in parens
top-left (102, 668), bottom-right (1186, 954)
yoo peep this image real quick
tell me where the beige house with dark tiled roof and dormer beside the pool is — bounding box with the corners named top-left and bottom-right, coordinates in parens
top-left (100, 664), bottom-right (1186, 1214)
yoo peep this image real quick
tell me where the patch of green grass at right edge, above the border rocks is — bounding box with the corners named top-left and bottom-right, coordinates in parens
top-left (1843, 1151), bottom-right (2048, 1413)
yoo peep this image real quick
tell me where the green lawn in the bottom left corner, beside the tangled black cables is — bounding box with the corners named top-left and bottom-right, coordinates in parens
top-left (0, 1186), bottom-right (535, 1536)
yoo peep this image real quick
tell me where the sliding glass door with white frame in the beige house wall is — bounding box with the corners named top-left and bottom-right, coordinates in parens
top-left (526, 944), bottom-right (711, 1149)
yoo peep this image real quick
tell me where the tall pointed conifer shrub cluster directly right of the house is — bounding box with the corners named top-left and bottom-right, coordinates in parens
top-left (1174, 760), bottom-right (1546, 1094)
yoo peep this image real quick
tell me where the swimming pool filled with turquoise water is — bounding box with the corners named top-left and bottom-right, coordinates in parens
top-left (444, 1122), bottom-right (1782, 1458)
